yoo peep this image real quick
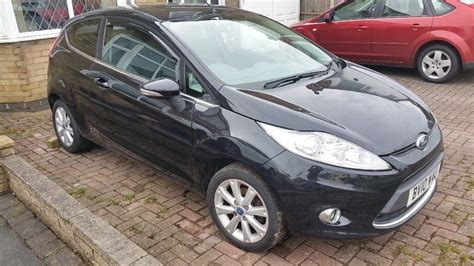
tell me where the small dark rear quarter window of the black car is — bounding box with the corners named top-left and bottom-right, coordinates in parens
top-left (66, 19), bottom-right (101, 57)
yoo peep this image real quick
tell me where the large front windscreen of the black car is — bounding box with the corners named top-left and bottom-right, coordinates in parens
top-left (163, 13), bottom-right (332, 89)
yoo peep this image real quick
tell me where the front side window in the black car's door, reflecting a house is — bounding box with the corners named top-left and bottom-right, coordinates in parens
top-left (102, 20), bottom-right (177, 80)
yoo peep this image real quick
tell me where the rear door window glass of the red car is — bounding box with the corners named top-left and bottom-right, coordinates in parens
top-left (382, 0), bottom-right (427, 17)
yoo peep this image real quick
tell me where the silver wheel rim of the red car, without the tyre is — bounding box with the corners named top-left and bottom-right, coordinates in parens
top-left (422, 50), bottom-right (452, 79)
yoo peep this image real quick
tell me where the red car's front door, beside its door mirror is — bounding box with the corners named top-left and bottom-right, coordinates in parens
top-left (317, 0), bottom-right (380, 62)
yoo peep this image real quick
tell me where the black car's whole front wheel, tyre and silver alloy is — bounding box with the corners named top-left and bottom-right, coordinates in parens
top-left (207, 163), bottom-right (286, 252)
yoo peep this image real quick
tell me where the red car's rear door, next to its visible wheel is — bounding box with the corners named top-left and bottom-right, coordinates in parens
top-left (372, 0), bottom-right (433, 65)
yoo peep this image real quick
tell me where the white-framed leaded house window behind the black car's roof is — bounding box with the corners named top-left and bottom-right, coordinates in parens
top-left (0, 0), bottom-right (127, 43)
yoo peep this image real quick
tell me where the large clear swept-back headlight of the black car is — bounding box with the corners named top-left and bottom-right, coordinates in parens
top-left (258, 123), bottom-right (391, 170)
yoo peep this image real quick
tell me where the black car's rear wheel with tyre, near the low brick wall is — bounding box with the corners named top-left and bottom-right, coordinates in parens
top-left (53, 100), bottom-right (92, 153)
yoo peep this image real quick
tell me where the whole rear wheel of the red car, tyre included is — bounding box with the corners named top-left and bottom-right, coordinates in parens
top-left (416, 44), bottom-right (461, 83)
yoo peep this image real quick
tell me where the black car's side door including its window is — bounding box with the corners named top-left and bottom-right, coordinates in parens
top-left (87, 18), bottom-right (194, 179)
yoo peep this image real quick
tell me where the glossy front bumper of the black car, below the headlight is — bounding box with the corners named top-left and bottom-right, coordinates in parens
top-left (261, 127), bottom-right (443, 238)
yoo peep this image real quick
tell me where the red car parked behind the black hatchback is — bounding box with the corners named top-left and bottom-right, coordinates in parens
top-left (292, 0), bottom-right (474, 83)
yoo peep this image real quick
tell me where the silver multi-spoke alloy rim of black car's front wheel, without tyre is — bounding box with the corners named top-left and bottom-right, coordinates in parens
top-left (214, 179), bottom-right (268, 243)
